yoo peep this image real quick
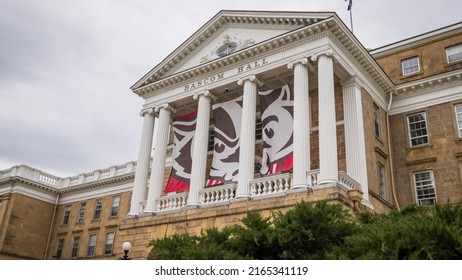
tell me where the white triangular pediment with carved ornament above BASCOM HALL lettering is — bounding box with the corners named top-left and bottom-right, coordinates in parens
top-left (131, 11), bottom-right (334, 90)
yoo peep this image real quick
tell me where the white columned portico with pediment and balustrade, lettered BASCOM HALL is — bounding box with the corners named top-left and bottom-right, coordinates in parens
top-left (129, 9), bottom-right (389, 216)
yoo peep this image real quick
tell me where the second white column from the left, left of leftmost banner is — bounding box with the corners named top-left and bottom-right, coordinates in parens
top-left (144, 104), bottom-right (174, 213)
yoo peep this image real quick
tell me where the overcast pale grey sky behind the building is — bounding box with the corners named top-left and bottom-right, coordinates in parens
top-left (0, 0), bottom-right (462, 177)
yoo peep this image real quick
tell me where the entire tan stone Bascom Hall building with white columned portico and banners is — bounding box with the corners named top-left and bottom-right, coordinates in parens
top-left (0, 11), bottom-right (462, 259)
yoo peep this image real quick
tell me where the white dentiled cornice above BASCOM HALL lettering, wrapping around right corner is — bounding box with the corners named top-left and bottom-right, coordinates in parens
top-left (132, 15), bottom-right (393, 98)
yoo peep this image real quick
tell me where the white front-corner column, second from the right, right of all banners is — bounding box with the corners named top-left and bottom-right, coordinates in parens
top-left (312, 51), bottom-right (338, 184)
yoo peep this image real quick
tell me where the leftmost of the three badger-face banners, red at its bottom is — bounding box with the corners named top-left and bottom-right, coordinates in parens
top-left (164, 111), bottom-right (197, 193)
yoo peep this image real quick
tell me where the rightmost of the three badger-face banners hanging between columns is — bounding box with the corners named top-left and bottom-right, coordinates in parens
top-left (258, 85), bottom-right (294, 174)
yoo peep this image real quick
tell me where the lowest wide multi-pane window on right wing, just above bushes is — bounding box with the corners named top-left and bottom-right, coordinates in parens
top-left (414, 171), bottom-right (436, 206)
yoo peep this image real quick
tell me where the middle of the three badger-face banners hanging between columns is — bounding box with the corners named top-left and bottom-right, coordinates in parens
top-left (207, 97), bottom-right (242, 186)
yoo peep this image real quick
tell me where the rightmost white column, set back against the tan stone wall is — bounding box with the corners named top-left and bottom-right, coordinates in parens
top-left (342, 77), bottom-right (370, 204)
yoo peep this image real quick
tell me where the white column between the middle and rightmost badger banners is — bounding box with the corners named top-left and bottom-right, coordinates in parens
top-left (236, 75), bottom-right (261, 198)
